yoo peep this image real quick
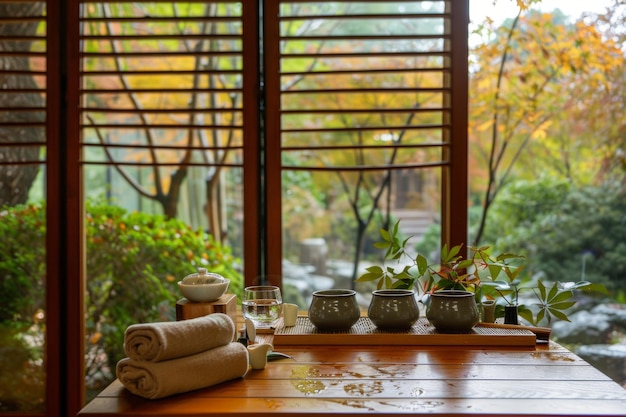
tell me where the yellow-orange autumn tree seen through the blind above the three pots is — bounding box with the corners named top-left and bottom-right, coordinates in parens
top-left (282, 3), bottom-right (443, 281)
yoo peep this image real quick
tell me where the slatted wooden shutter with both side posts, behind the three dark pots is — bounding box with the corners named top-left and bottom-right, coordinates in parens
top-left (264, 0), bottom-right (468, 280)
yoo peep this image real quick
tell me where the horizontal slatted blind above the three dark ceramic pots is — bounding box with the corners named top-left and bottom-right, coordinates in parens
top-left (278, 1), bottom-right (450, 171)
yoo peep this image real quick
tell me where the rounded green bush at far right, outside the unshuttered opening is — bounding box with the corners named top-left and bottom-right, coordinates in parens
top-left (486, 177), bottom-right (626, 293)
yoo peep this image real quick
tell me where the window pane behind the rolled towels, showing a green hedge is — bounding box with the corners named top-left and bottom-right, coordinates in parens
top-left (80, 2), bottom-right (245, 397)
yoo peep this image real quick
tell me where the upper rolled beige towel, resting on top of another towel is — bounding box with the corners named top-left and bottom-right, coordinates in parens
top-left (124, 313), bottom-right (235, 362)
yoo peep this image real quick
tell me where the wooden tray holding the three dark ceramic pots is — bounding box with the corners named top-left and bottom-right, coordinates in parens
top-left (274, 317), bottom-right (536, 348)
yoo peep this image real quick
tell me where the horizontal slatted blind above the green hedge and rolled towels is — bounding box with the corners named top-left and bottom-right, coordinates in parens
top-left (80, 1), bottom-right (244, 169)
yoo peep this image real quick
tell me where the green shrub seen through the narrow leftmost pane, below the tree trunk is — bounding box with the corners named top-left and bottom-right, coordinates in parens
top-left (0, 205), bottom-right (46, 413)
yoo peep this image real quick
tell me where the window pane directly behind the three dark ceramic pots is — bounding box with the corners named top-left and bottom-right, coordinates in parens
top-left (278, 1), bottom-right (450, 308)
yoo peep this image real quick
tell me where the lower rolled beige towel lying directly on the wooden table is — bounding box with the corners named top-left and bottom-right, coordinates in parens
top-left (116, 342), bottom-right (248, 399)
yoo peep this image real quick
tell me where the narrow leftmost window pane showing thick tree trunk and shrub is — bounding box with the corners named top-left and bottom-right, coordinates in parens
top-left (0, 2), bottom-right (47, 413)
